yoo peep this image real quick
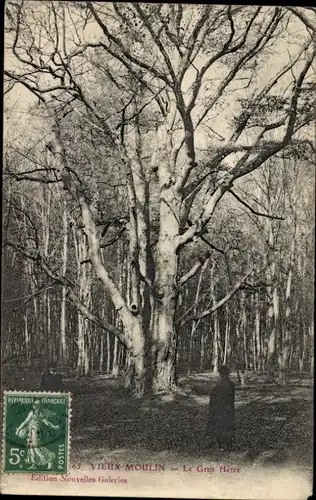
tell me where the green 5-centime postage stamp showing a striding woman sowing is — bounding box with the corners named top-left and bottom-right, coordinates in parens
top-left (2, 391), bottom-right (71, 474)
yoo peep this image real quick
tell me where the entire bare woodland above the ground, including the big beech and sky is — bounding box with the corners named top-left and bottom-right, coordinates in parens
top-left (2, 1), bottom-right (316, 397)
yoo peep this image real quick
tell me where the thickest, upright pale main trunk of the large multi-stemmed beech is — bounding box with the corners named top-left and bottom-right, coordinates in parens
top-left (146, 176), bottom-right (181, 392)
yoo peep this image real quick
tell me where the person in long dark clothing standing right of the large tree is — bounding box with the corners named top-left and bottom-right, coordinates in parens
top-left (207, 366), bottom-right (235, 451)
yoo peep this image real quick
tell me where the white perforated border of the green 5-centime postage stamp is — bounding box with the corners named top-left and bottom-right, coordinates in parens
top-left (1, 390), bottom-right (72, 476)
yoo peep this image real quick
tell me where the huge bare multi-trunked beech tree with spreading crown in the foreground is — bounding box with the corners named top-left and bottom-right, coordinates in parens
top-left (5, 1), bottom-right (315, 395)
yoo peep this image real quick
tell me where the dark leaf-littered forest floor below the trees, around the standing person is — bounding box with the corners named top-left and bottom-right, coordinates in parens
top-left (67, 373), bottom-right (313, 470)
